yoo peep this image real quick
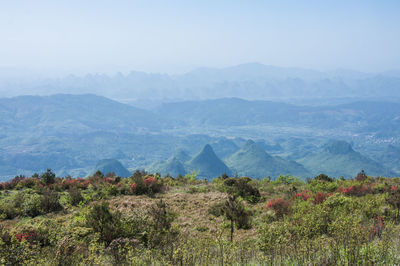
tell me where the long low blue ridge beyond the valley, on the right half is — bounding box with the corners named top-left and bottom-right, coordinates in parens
top-left (155, 98), bottom-right (400, 136)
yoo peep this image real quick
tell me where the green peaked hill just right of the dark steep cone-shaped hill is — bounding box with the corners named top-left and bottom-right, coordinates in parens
top-left (226, 140), bottom-right (309, 178)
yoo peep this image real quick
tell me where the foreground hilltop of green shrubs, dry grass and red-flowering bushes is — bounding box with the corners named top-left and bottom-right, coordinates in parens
top-left (0, 170), bottom-right (400, 265)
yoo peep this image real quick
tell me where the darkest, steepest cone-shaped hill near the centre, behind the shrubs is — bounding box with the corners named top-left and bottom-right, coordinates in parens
top-left (187, 144), bottom-right (231, 178)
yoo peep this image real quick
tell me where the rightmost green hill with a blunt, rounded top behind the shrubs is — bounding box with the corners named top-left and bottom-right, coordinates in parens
top-left (297, 140), bottom-right (393, 177)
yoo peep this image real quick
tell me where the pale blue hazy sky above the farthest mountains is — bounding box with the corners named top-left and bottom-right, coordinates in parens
top-left (0, 0), bottom-right (400, 73)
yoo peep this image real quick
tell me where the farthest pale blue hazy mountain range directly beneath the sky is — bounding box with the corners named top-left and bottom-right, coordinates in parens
top-left (0, 63), bottom-right (400, 103)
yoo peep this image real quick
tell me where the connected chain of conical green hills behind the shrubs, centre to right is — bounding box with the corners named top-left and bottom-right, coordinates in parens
top-left (147, 140), bottom-right (394, 178)
